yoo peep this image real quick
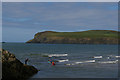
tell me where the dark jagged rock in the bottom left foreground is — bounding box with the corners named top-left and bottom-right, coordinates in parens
top-left (0, 49), bottom-right (38, 80)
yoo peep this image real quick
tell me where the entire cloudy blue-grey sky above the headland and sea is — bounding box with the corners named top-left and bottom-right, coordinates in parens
top-left (2, 2), bottom-right (118, 42)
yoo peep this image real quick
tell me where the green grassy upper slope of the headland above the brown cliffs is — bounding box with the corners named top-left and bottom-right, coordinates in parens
top-left (35, 30), bottom-right (118, 38)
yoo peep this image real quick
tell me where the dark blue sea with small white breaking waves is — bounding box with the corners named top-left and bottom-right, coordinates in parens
top-left (2, 43), bottom-right (119, 78)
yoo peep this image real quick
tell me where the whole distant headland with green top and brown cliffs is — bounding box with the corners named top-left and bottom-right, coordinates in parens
top-left (26, 30), bottom-right (119, 44)
